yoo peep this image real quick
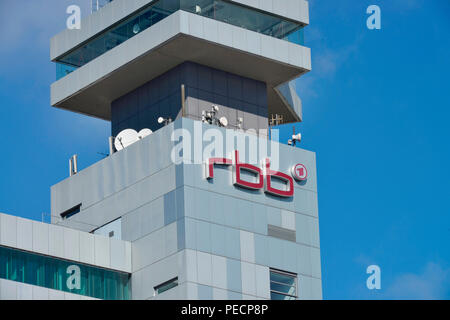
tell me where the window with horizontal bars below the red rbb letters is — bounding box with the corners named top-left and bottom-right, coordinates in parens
top-left (270, 269), bottom-right (298, 300)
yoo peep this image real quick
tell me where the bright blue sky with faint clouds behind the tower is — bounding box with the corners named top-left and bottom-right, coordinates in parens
top-left (0, 0), bottom-right (450, 299)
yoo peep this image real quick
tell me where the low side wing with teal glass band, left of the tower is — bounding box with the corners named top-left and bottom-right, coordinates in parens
top-left (0, 214), bottom-right (132, 300)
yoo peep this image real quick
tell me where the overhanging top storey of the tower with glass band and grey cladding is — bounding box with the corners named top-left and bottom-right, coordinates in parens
top-left (51, 0), bottom-right (311, 122)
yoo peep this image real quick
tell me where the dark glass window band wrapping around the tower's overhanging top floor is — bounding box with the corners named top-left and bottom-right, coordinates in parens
top-left (57, 0), bottom-right (304, 80)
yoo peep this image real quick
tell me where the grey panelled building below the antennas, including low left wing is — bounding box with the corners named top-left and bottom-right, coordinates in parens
top-left (0, 118), bottom-right (322, 300)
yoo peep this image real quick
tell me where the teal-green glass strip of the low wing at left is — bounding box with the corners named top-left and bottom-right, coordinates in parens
top-left (0, 246), bottom-right (130, 300)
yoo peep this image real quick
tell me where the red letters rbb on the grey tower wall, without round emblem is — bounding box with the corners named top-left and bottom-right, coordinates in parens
top-left (205, 150), bottom-right (294, 198)
